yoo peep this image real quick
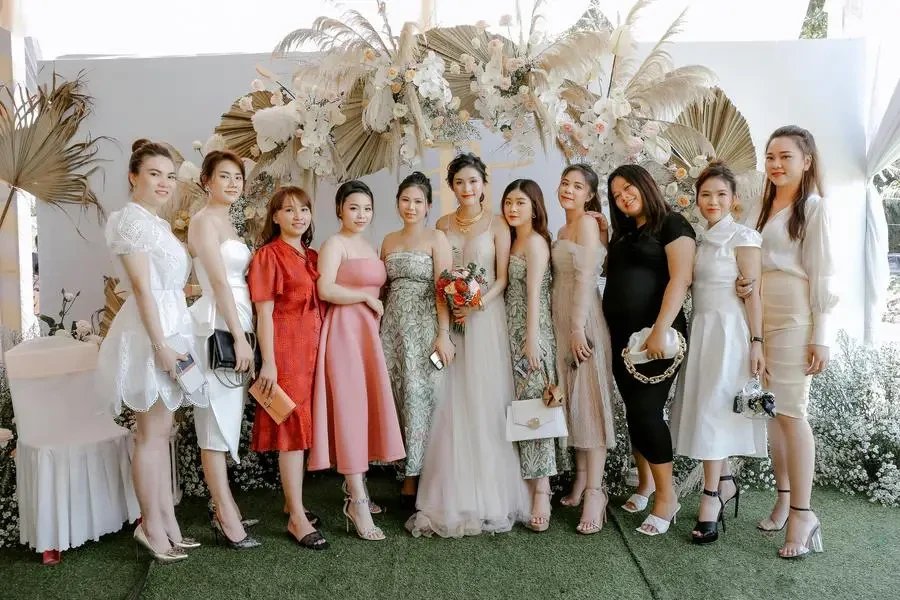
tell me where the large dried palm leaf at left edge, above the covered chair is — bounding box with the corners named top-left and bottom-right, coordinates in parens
top-left (0, 73), bottom-right (108, 227)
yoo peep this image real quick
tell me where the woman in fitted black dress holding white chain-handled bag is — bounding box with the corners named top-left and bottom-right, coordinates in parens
top-left (603, 165), bottom-right (696, 535)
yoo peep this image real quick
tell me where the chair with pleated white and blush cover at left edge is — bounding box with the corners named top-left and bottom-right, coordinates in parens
top-left (5, 337), bottom-right (140, 552)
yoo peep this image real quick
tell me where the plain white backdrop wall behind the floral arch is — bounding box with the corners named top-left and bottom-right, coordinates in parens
top-left (38, 40), bottom-right (865, 335)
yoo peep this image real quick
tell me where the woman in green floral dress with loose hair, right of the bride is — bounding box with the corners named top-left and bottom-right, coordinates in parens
top-left (503, 179), bottom-right (565, 531)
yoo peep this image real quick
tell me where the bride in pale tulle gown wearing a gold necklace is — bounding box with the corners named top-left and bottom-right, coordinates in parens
top-left (406, 154), bottom-right (530, 537)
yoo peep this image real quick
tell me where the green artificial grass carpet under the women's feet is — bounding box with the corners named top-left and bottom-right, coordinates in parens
top-left (0, 476), bottom-right (900, 600)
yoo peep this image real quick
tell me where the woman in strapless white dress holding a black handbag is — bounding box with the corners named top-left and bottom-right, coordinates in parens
top-left (188, 150), bottom-right (259, 549)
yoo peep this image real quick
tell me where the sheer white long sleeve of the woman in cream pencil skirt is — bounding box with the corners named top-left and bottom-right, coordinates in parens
top-left (800, 197), bottom-right (838, 346)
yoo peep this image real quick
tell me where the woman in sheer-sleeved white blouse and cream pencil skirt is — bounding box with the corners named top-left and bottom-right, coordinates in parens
top-left (739, 125), bottom-right (838, 558)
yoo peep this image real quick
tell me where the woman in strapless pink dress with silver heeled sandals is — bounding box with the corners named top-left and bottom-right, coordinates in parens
top-left (309, 181), bottom-right (406, 540)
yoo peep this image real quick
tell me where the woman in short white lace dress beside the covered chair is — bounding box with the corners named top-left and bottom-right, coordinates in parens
top-left (99, 140), bottom-right (208, 562)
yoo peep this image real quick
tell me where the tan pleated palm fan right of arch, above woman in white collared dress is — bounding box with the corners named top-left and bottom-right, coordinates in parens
top-left (663, 88), bottom-right (756, 173)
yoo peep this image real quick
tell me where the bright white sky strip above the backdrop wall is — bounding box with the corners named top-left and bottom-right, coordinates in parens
top-left (18, 0), bottom-right (809, 60)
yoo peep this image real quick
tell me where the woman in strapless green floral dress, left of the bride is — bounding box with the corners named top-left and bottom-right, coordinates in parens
top-left (381, 171), bottom-right (454, 506)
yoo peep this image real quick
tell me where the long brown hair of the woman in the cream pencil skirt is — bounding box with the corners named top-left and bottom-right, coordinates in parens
top-left (756, 125), bottom-right (825, 242)
